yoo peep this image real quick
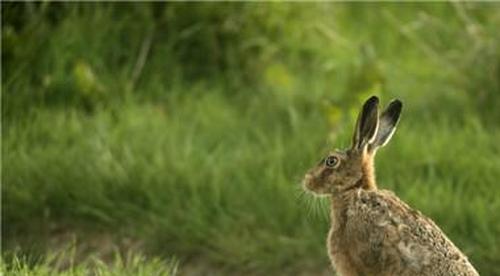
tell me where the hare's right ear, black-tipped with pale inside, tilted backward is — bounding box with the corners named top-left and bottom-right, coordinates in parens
top-left (368, 100), bottom-right (403, 151)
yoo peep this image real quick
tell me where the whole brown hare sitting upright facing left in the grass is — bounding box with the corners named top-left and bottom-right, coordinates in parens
top-left (303, 96), bottom-right (479, 276)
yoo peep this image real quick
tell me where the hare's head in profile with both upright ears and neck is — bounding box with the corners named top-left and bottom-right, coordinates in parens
top-left (303, 96), bottom-right (403, 195)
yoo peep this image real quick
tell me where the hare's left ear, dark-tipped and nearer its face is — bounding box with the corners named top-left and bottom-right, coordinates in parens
top-left (351, 96), bottom-right (378, 150)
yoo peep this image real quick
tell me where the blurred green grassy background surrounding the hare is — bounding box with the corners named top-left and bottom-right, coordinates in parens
top-left (0, 2), bottom-right (500, 275)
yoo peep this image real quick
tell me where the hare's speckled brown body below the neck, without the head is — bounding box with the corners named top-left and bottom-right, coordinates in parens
top-left (327, 188), bottom-right (478, 276)
